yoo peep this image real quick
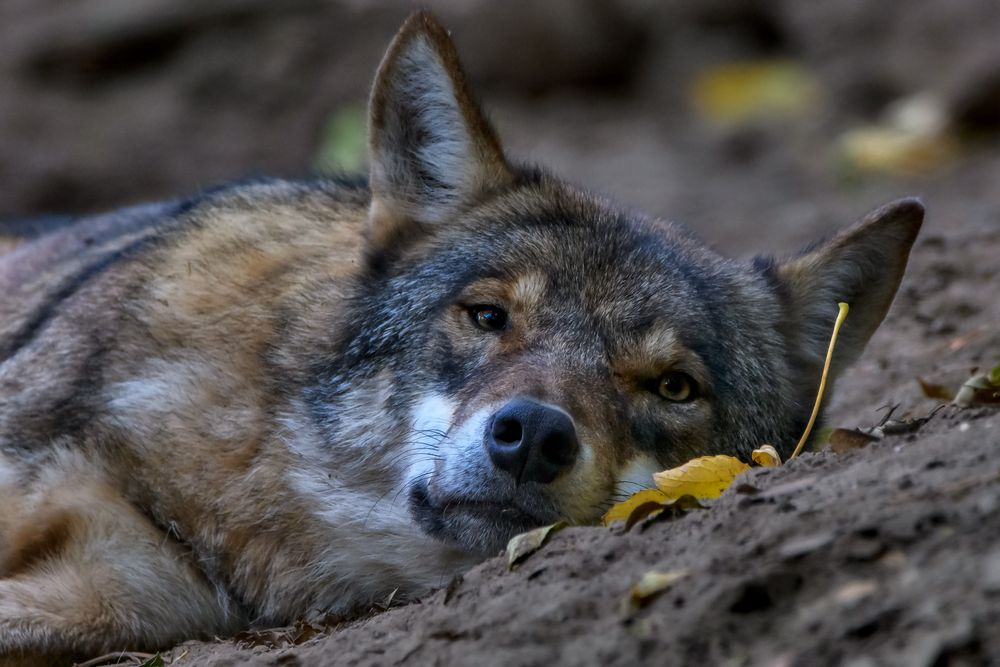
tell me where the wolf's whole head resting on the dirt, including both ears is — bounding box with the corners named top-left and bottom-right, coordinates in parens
top-left (300, 14), bottom-right (923, 553)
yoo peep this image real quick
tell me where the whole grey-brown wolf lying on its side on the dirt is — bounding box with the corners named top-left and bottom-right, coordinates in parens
top-left (0, 13), bottom-right (923, 664)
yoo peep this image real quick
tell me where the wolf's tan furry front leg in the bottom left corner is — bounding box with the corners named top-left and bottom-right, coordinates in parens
top-left (0, 455), bottom-right (241, 665)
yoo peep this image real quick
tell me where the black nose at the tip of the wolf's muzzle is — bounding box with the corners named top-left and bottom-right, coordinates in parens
top-left (486, 398), bottom-right (580, 484)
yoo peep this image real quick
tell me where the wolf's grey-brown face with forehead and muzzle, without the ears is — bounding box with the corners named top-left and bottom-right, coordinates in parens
top-left (363, 190), bottom-right (792, 552)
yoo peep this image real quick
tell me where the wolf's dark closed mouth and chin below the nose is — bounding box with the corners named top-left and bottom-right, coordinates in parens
top-left (410, 484), bottom-right (558, 555)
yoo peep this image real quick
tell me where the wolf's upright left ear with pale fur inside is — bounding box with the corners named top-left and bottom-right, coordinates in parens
top-left (368, 12), bottom-right (511, 246)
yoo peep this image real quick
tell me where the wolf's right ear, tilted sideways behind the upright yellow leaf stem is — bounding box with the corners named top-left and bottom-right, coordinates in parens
top-left (776, 199), bottom-right (924, 388)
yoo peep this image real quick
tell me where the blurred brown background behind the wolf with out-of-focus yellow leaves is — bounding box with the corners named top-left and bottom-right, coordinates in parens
top-left (0, 0), bottom-right (1000, 255)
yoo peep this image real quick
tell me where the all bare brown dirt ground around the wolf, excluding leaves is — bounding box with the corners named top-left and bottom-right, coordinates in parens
top-left (0, 0), bottom-right (1000, 667)
